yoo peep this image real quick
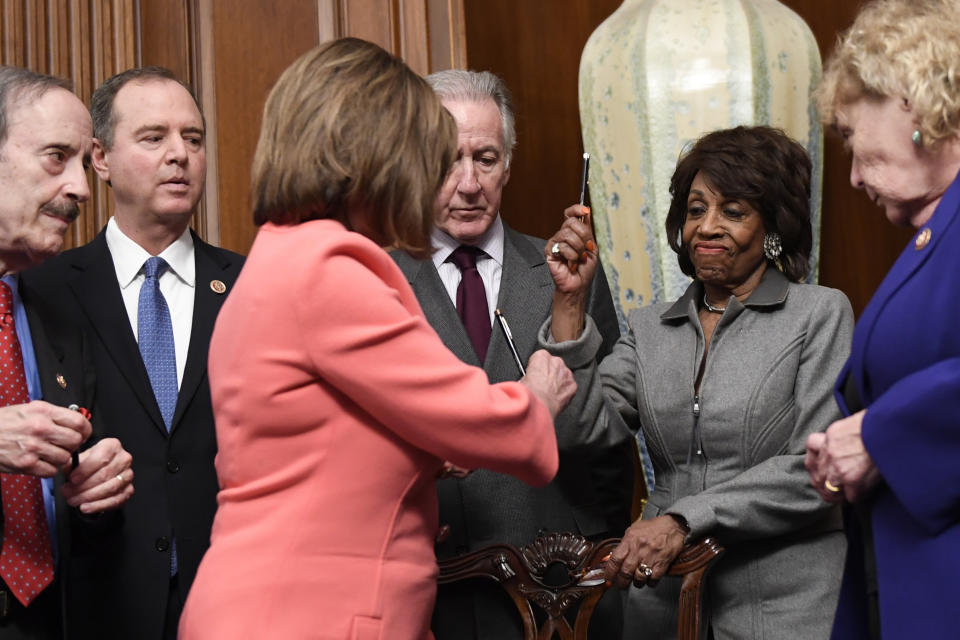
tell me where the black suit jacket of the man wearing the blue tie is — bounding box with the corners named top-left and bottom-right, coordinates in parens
top-left (26, 232), bottom-right (243, 640)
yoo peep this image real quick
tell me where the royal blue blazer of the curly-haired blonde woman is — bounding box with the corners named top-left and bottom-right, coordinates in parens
top-left (833, 170), bottom-right (960, 640)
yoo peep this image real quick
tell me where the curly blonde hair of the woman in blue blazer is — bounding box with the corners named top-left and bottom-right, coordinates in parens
top-left (816, 0), bottom-right (960, 147)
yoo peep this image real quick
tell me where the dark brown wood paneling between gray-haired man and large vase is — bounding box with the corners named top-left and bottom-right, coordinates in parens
top-left (464, 0), bottom-right (620, 237)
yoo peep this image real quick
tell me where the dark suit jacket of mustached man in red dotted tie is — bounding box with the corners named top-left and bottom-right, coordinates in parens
top-left (0, 283), bottom-right (96, 639)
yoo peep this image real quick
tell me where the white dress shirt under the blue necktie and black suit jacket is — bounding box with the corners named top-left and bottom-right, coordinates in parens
top-left (107, 217), bottom-right (197, 389)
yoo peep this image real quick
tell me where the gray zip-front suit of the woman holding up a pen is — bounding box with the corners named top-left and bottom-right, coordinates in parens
top-left (541, 269), bottom-right (853, 640)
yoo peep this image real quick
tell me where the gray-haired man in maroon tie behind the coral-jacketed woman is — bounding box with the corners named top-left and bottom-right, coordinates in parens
top-left (392, 71), bottom-right (633, 640)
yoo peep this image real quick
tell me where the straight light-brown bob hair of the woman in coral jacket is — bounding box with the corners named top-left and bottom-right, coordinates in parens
top-left (251, 38), bottom-right (457, 257)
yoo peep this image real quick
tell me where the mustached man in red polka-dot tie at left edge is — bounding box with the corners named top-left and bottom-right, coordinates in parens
top-left (0, 67), bottom-right (133, 640)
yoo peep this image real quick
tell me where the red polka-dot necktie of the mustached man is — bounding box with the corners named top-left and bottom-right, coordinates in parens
top-left (0, 282), bottom-right (53, 606)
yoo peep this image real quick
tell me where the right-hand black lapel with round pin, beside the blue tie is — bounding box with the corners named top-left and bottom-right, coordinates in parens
top-left (171, 238), bottom-right (232, 431)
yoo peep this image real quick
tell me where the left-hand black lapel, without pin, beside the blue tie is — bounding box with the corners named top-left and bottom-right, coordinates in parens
top-left (68, 231), bottom-right (167, 434)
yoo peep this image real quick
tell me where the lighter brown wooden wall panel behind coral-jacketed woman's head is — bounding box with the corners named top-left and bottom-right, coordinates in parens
top-left (203, 0), bottom-right (465, 253)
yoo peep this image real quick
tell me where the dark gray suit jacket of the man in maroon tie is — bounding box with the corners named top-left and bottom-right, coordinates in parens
top-left (391, 225), bottom-right (633, 640)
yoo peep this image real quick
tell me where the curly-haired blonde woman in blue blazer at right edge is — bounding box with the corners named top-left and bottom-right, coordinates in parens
top-left (806, 0), bottom-right (960, 639)
